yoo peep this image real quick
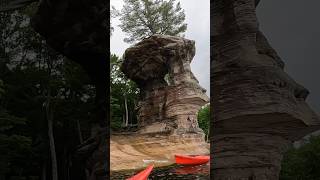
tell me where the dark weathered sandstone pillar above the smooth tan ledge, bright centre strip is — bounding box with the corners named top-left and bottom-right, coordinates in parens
top-left (121, 35), bottom-right (208, 134)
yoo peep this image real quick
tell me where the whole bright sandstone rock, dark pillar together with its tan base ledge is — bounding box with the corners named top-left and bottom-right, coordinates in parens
top-left (114, 35), bottom-right (209, 171)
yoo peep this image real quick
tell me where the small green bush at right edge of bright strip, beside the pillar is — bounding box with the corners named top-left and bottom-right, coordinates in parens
top-left (198, 104), bottom-right (210, 141)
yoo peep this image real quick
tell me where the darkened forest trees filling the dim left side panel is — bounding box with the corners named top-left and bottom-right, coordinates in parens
top-left (0, 9), bottom-right (95, 180)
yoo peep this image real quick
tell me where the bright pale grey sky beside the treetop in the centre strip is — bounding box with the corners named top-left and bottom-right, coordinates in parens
top-left (110, 0), bottom-right (210, 96)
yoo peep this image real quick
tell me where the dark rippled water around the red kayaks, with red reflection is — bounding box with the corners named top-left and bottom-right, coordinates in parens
top-left (111, 164), bottom-right (210, 180)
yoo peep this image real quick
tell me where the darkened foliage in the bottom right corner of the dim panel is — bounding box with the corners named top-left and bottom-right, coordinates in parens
top-left (280, 136), bottom-right (320, 180)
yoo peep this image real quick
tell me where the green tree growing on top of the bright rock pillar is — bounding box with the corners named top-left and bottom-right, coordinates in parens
top-left (119, 0), bottom-right (187, 43)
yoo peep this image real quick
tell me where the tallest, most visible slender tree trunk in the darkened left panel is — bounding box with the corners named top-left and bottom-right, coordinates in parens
top-left (46, 87), bottom-right (58, 180)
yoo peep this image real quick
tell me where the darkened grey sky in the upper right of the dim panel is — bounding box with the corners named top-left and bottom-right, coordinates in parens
top-left (257, 0), bottom-right (320, 113)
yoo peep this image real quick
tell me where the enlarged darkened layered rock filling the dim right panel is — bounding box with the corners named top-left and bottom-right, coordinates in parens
top-left (211, 0), bottom-right (320, 180)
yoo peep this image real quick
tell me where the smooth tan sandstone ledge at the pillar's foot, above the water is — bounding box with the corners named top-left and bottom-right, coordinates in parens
top-left (110, 133), bottom-right (210, 173)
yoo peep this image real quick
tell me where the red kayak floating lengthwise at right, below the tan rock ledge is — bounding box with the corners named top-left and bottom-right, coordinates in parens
top-left (175, 155), bottom-right (210, 165)
